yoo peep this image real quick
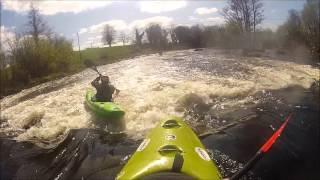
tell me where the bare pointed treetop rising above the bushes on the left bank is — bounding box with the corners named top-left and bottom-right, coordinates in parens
top-left (27, 4), bottom-right (52, 44)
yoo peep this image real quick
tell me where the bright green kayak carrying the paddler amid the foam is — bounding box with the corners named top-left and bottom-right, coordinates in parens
top-left (86, 90), bottom-right (125, 119)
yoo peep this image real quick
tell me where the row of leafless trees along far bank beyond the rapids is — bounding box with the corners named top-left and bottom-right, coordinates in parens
top-left (102, 0), bottom-right (320, 61)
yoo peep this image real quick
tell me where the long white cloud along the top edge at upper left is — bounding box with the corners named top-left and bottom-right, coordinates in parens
top-left (2, 0), bottom-right (112, 15)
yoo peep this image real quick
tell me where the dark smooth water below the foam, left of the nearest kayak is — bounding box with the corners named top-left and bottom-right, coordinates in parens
top-left (0, 129), bottom-right (137, 179)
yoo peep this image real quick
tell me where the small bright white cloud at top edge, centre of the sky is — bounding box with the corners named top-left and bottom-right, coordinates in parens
top-left (139, 1), bottom-right (187, 13)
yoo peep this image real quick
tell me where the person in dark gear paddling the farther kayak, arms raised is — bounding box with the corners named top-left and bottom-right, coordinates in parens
top-left (91, 76), bottom-right (120, 102)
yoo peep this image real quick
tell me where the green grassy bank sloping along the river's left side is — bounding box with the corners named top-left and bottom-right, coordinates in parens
top-left (1, 45), bottom-right (157, 98)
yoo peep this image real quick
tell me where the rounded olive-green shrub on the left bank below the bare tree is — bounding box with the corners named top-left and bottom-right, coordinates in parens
top-left (12, 37), bottom-right (74, 78)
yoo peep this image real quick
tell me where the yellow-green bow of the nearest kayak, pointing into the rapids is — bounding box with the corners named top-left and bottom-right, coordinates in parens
top-left (117, 117), bottom-right (221, 180)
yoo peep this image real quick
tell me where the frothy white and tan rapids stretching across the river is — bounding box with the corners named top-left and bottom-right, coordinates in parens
top-left (0, 49), bottom-right (320, 142)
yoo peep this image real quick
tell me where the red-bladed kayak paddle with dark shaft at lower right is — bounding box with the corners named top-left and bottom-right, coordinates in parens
top-left (230, 114), bottom-right (291, 180)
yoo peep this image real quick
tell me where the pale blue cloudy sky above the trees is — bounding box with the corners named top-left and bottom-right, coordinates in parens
top-left (1, 0), bottom-right (305, 49)
